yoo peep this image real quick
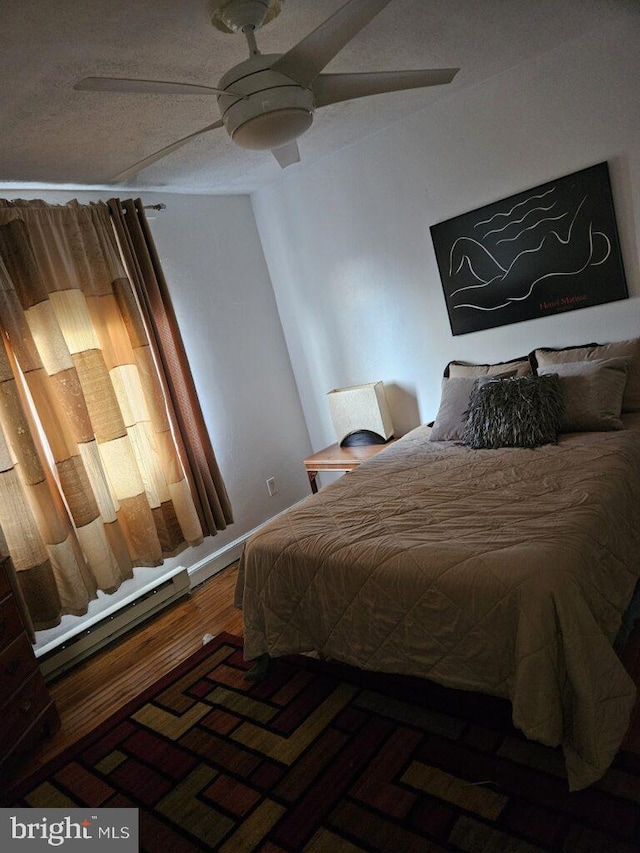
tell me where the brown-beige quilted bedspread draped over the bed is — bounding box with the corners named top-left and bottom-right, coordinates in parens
top-left (236, 415), bottom-right (640, 790)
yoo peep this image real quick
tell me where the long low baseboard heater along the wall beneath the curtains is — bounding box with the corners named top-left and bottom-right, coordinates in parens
top-left (36, 569), bottom-right (191, 681)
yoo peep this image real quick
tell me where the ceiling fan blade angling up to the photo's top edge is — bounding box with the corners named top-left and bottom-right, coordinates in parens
top-left (271, 0), bottom-right (391, 86)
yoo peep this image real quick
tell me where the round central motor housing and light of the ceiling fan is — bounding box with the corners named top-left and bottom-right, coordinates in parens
top-left (218, 54), bottom-right (314, 150)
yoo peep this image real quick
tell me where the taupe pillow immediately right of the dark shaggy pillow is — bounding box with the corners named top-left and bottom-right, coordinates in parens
top-left (538, 351), bottom-right (629, 432)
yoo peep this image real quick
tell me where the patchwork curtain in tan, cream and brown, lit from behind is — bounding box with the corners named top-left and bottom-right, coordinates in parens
top-left (0, 201), bottom-right (230, 630)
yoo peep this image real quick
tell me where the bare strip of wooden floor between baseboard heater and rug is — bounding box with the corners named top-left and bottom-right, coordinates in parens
top-left (7, 564), bottom-right (242, 781)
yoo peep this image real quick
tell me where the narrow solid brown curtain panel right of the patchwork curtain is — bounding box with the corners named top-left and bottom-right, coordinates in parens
top-left (108, 199), bottom-right (233, 535)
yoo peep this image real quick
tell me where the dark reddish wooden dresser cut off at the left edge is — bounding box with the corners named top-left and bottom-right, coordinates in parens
top-left (0, 559), bottom-right (60, 778)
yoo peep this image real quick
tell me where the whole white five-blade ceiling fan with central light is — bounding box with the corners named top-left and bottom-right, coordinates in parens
top-left (74, 0), bottom-right (459, 180)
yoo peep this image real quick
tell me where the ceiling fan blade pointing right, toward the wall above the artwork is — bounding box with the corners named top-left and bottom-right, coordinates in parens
top-left (311, 68), bottom-right (460, 107)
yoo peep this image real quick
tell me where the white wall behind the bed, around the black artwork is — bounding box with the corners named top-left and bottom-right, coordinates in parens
top-left (252, 13), bottom-right (640, 449)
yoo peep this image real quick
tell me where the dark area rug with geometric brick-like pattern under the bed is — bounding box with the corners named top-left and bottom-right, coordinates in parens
top-left (7, 634), bottom-right (640, 853)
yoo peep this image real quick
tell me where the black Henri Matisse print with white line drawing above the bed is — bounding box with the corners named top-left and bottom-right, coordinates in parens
top-left (430, 163), bottom-right (629, 335)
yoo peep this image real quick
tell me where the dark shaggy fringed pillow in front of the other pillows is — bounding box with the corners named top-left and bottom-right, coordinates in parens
top-left (462, 373), bottom-right (564, 450)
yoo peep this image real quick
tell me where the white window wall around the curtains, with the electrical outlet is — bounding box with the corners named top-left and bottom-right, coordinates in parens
top-left (3, 188), bottom-right (311, 580)
